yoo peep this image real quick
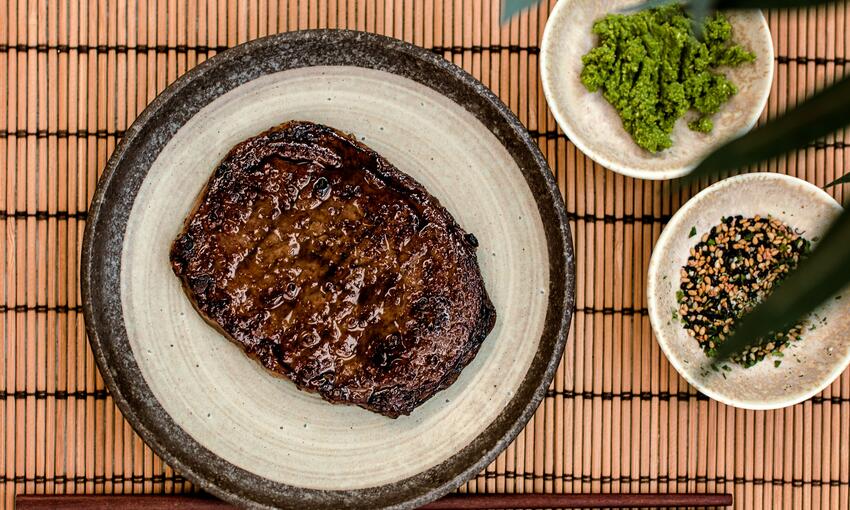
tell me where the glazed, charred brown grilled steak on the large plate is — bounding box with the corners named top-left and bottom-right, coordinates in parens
top-left (171, 122), bottom-right (496, 418)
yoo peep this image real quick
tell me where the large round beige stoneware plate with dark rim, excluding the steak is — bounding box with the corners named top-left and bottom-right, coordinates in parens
top-left (82, 31), bottom-right (574, 508)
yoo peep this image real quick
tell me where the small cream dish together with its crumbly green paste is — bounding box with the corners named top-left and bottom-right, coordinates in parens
top-left (540, 0), bottom-right (774, 179)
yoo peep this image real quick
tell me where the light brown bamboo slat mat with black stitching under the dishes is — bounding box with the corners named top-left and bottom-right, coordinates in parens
top-left (0, 0), bottom-right (850, 509)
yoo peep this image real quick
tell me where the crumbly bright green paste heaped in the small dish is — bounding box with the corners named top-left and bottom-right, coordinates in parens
top-left (581, 5), bottom-right (756, 152)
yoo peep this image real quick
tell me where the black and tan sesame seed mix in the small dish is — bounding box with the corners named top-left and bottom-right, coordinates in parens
top-left (673, 216), bottom-right (811, 367)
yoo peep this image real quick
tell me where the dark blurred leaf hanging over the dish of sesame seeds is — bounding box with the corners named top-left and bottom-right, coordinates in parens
top-left (715, 209), bottom-right (850, 363)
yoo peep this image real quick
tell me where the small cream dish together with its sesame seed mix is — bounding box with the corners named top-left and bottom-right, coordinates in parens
top-left (646, 173), bottom-right (850, 409)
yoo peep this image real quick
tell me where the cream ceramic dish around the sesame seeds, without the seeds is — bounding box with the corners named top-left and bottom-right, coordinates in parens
top-left (647, 173), bottom-right (850, 409)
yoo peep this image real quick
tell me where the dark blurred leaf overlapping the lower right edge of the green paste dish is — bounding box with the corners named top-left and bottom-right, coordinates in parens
top-left (684, 77), bottom-right (850, 183)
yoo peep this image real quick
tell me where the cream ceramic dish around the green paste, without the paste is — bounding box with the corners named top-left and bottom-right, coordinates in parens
top-left (540, 0), bottom-right (774, 179)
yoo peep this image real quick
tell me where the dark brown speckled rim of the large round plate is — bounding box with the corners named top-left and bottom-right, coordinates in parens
top-left (80, 30), bottom-right (575, 508)
